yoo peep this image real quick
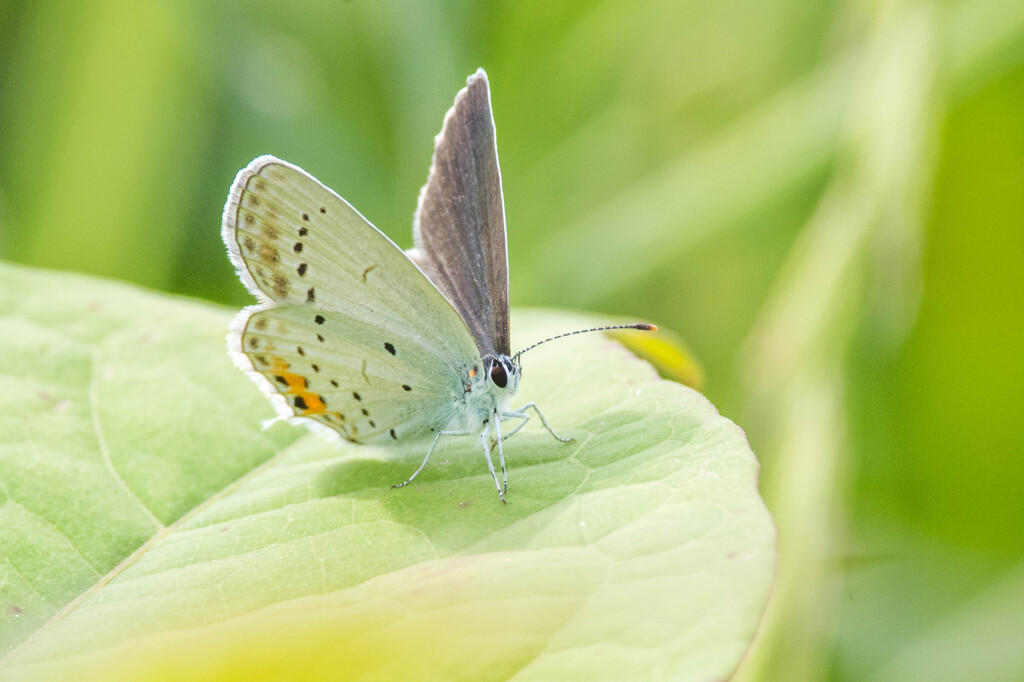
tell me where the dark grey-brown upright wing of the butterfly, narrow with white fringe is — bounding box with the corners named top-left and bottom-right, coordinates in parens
top-left (413, 69), bottom-right (510, 355)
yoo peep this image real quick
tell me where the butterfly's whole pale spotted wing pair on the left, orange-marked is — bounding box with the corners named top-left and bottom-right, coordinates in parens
top-left (222, 157), bottom-right (479, 442)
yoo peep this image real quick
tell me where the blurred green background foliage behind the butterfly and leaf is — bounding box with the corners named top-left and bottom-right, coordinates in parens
top-left (0, 0), bottom-right (1024, 680)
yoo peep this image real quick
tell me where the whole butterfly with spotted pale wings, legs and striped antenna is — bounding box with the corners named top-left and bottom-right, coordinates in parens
top-left (221, 69), bottom-right (655, 502)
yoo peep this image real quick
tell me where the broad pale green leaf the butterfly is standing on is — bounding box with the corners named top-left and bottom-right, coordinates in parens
top-left (0, 266), bottom-right (774, 680)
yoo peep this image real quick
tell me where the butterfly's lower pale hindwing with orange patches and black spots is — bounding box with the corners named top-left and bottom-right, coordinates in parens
top-left (230, 304), bottom-right (469, 442)
